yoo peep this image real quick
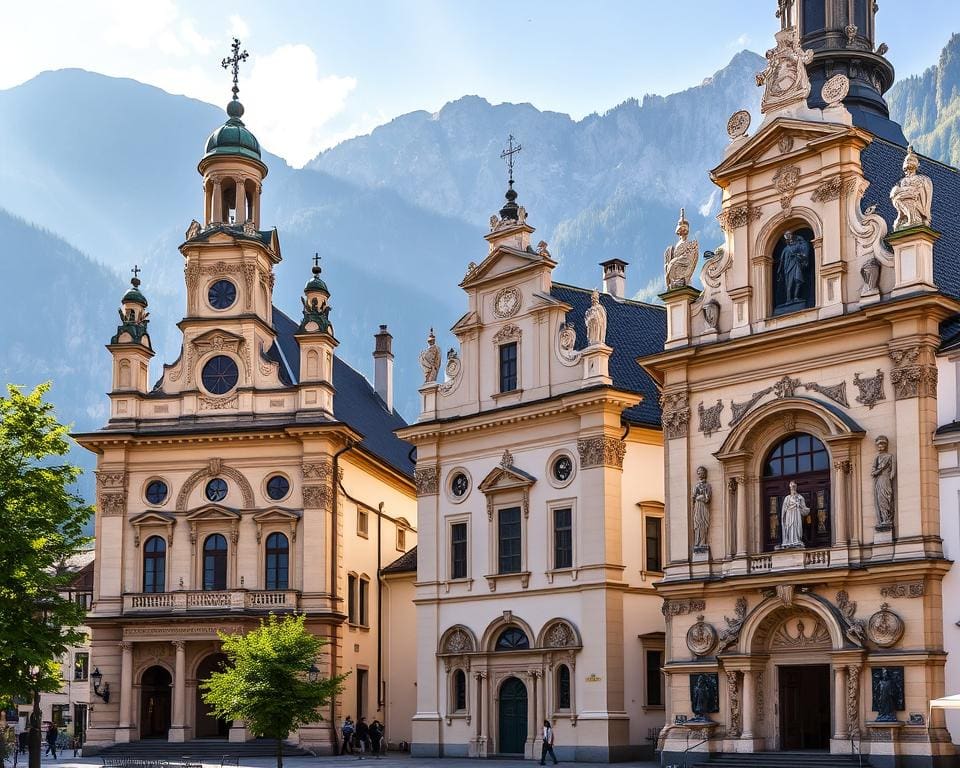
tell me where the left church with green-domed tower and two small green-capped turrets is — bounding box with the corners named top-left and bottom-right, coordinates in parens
top-left (76, 51), bottom-right (416, 753)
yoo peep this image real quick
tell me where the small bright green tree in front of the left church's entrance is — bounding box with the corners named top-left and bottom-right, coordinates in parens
top-left (200, 614), bottom-right (346, 768)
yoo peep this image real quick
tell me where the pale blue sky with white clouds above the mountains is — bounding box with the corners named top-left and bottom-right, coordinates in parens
top-left (0, 0), bottom-right (960, 165)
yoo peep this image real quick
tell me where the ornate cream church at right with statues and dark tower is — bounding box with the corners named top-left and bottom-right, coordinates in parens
top-left (641, 0), bottom-right (960, 766)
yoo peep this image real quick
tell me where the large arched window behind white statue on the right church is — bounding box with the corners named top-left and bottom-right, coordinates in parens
top-left (761, 433), bottom-right (831, 551)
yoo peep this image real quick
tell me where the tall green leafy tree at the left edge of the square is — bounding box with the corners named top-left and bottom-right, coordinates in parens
top-left (0, 383), bottom-right (93, 768)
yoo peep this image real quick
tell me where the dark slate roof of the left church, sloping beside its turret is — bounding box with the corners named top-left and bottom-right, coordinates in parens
top-left (267, 307), bottom-right (413, 478)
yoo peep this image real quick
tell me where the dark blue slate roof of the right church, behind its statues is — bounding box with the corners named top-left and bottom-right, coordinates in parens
top-left (860, 137), bottom-right (960, 345)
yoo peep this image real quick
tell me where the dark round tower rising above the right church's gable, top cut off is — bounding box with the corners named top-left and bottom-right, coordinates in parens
top-left (777, 0), bottom-right (907, 146)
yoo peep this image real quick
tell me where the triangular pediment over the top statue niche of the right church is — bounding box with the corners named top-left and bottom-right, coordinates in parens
top-left (710, 118), bottom-right (862, 180)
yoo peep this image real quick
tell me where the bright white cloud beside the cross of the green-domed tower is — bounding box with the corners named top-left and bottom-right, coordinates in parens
top-left (240, 45), bottom-right (357, 167)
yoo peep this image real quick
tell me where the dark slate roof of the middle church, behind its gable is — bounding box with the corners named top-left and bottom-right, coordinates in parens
top-left (550, 283), bottom-right (667, 429)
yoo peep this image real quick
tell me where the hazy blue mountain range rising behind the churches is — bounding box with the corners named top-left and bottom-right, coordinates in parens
top-left (0, 36), bottom-right (960, 498)
